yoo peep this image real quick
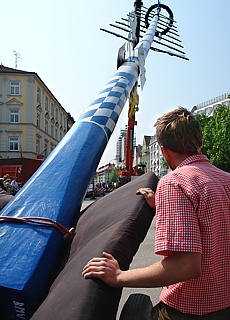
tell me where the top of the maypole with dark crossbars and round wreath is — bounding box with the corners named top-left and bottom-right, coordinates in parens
top-left (101, 0), bottom-right (189, 89)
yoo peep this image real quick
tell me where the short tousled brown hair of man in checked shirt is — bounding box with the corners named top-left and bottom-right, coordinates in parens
top-left (154, 107), bottom-right (203, 155)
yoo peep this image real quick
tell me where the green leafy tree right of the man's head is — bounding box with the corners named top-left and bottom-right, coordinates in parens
top-left (196, 105), bottom-right (230, 172)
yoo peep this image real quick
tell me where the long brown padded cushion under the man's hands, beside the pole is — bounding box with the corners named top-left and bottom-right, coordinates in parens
top-left (31, 172), bottom-right (158, 320)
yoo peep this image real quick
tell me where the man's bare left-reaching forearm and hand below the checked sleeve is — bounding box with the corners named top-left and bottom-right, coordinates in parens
top-left (82, 252), bottom-right (202, 288)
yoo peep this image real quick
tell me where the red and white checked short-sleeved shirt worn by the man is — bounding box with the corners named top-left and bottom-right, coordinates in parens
top-left (155, 155), bottom-right (230, 315)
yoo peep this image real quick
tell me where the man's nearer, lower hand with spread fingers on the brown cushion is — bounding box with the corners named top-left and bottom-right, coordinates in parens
top-left (82, 252), bottom-right (122, 287)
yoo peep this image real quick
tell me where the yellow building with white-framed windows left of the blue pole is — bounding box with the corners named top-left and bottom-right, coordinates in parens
top-left (0, 65), bottom-right (74, 159)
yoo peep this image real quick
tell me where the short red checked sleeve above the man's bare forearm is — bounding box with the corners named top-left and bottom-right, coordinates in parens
top-left (155, 179), bottom-right (202, 256)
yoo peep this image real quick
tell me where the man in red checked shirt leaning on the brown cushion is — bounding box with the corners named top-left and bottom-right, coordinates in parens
top-left (83, 107), bottom-right (230, 320)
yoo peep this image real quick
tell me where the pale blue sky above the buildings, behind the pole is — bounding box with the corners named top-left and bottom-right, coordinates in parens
top-left (0, 0), bottom-right (230, 165)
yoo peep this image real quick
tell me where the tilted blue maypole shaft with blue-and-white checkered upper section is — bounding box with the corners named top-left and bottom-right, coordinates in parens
top-left (0, 8), bottom-right (161, 319)
